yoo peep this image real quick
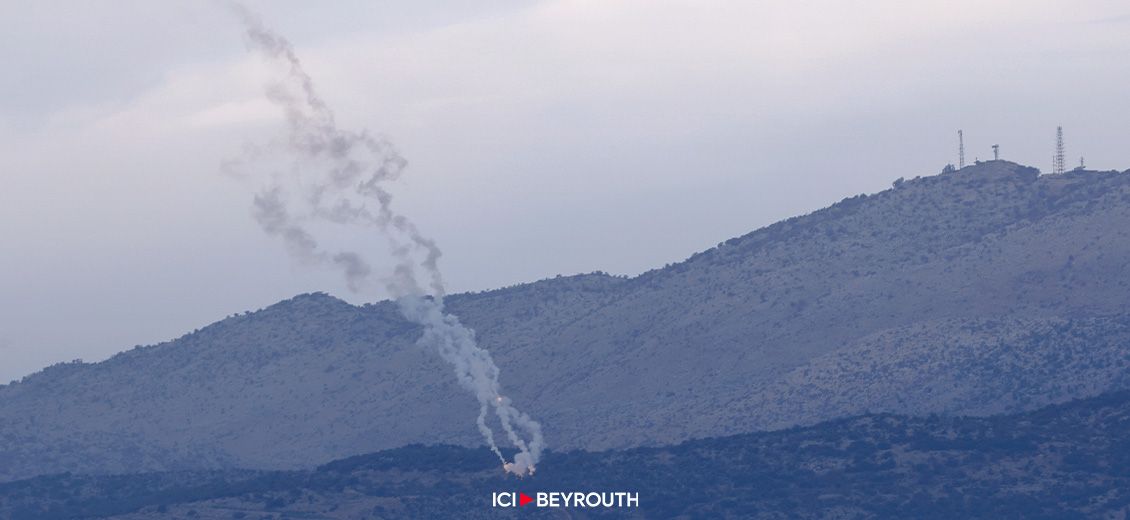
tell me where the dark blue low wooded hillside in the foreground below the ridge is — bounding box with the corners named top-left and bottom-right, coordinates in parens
top-left (0, 392), bottom-right (1130, 520)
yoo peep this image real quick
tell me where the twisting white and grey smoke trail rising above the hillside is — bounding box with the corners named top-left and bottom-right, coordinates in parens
top-left (225, 3), bottom-right (544, 475)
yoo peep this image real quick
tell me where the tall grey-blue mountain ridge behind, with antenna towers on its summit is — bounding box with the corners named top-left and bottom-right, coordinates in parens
top-left (0, 161), bottom-right (1130, 480)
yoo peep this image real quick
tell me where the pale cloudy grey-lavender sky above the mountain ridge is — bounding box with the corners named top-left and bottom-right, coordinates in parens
top-left (0, 0), bottom-right (1130, 381)
